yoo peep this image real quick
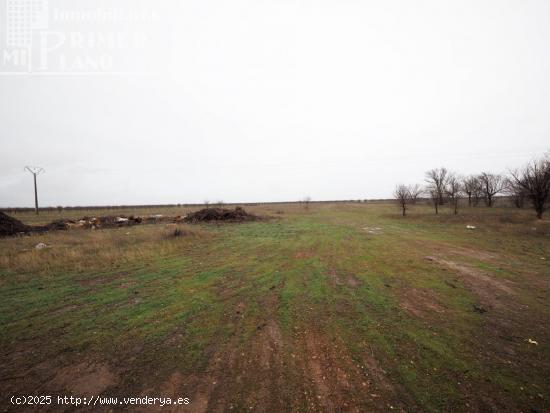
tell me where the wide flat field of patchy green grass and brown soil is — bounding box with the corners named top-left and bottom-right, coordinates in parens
top-left (0, 204), bottom-right (550, 412)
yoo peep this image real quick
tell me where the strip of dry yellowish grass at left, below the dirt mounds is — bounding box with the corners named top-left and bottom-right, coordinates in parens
top-left (0, 225), bottom-right (212, 275)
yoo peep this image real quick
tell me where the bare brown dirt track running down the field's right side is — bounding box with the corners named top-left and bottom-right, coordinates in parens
top-left (425, 255), bottom-right (550, 412)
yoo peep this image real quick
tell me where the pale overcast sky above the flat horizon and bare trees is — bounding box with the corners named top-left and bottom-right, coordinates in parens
top-left (0, 0), bottom-right (550, 206)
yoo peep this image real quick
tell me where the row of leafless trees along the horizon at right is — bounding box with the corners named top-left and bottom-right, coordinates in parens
top-left (394, 152), bottom-right (550, 219)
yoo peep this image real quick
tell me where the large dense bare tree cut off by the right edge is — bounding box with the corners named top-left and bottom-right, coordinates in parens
top-left (511, 156), bottom-right (550, 219)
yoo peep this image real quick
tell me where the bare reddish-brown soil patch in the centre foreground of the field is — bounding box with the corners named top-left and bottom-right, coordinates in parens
top-left (130, 274), bottom-right (414, 413)
